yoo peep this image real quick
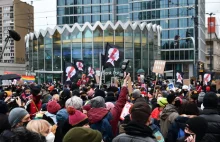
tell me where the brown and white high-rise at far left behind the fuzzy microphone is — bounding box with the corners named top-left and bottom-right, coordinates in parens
top-left (0, 0), bottom-right (34, 64)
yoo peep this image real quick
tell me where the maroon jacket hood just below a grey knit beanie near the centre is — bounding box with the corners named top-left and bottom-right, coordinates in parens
top-left (87, 108), bottom-right (109, 124)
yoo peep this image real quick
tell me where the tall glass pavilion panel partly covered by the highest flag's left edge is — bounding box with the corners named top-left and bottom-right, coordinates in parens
top-left (93, 26), bottom-right (103, 68)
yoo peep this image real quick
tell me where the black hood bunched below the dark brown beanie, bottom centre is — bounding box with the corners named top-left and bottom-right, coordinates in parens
top-left (124, 121), bottom-right (155, 138)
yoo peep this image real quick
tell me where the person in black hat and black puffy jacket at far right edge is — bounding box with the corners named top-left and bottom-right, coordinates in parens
top-left (201, 92), bottom-right (220, 142)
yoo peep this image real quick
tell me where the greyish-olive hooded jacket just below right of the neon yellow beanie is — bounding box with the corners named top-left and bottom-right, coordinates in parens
top-left (160, 104), bottom-right (179, 139)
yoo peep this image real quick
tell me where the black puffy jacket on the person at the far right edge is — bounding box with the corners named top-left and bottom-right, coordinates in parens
top-left (200, 108), bottom-right (220, 142)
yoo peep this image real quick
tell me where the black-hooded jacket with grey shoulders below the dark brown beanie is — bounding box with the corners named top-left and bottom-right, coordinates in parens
top-left (112, 121), bottom-right (156, 142)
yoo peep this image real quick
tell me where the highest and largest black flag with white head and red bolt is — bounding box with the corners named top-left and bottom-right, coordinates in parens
top-left (102, 43), bottom-right (120, 69)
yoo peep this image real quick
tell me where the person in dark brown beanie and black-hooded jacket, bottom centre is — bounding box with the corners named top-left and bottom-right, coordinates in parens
top-left (112, 102), bottom-right (155, 142)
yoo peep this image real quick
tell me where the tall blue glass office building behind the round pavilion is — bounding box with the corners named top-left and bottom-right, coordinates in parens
top-left (57, 0), bottom-right (205, 78)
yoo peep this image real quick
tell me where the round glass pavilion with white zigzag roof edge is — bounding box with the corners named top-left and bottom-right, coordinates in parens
top-left (25, 21), bottom-right (161, 83)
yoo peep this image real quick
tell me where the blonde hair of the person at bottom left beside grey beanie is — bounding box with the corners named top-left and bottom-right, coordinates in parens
top-left (26, 119), bottom-right (51, 137)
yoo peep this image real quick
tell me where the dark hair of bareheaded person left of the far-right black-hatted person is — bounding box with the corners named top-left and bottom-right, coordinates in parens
top-left (179, 102), bottom-right (199, 115)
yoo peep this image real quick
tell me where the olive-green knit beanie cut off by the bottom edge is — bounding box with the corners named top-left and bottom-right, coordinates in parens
top-left (63, 127), bottom-right (102, 142)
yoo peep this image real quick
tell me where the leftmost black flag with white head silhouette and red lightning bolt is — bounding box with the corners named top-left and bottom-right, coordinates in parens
top-left (63, 62), bottom-right (76, 81)
